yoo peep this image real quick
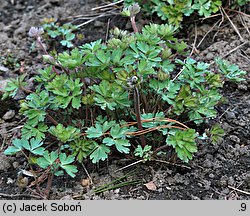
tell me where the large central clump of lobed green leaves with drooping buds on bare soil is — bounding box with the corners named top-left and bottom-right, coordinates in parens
top-left (1, 5), bottom-right (247, 197)
